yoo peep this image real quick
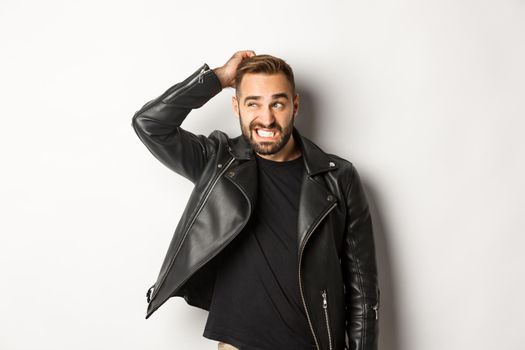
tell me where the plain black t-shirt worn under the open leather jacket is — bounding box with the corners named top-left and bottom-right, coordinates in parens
top-left (203, 155), bottom-right (316, 350)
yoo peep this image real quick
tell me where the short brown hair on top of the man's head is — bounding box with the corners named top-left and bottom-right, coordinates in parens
top-left (235, 55), bottom-right (295, 95)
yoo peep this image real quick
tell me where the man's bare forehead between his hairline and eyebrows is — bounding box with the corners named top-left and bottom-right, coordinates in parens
top-left (237, 72), bottom-right (292, 97)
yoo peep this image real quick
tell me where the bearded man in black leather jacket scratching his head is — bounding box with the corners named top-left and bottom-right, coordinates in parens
top-left (132, 51), bottom-right (379, 350)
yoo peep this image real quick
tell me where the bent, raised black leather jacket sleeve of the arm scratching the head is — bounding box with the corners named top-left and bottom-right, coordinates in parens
top-left (131, 63), bottom-right (222, 183)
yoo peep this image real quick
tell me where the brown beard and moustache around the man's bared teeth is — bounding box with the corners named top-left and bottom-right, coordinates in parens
top-left (239, 111), bottom-right (295, 155)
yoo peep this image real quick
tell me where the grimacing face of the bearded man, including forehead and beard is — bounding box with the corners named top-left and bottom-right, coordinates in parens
top-left (232, 73), bottom-right (299, 155)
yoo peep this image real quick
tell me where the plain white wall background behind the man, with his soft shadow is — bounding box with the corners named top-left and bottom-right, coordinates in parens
top-left (0, 0), bottom-right (525, 350)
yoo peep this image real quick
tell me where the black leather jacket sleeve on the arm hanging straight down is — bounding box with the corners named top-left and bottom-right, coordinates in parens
top-left (341, 164), bottom-right (379, 350)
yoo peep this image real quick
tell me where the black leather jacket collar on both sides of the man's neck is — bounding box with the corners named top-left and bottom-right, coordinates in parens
top-left (228, 126), bottom-right (338, 176)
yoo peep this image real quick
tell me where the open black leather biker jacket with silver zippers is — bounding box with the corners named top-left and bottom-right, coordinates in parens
top-left (132, 64), bottom-right (379, 350)
